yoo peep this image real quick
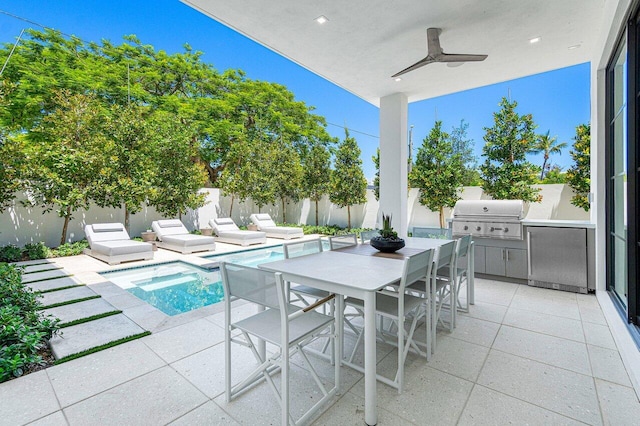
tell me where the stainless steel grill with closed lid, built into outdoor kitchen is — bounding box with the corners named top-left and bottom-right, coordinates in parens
top-left (451, 200), bottom-right (524, 240)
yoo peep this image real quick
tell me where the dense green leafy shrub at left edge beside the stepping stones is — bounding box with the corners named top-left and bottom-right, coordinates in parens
top-left (0, 263), bottom-right (59, 382)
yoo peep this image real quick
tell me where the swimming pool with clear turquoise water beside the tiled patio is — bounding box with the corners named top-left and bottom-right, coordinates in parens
top-left (100, 241), bottom-right (328, 316)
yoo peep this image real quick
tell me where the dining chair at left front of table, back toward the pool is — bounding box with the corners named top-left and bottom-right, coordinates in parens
top-left (220, 262), bottom-right (340, 425)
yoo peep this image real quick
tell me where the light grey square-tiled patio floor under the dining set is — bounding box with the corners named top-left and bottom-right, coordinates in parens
top-left (0, 248), bottom-right (640, 425)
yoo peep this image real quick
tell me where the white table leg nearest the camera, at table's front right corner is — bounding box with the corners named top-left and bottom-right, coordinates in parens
top-left (364, 291), bottom-right (378, 426)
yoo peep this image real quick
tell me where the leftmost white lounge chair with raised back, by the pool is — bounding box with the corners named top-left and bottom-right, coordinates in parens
top-left (84, 223), bottom-right (153, 265)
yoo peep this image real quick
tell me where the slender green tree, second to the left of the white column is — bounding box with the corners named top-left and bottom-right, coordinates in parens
top-left (302, 144), bottom-right (331, 226)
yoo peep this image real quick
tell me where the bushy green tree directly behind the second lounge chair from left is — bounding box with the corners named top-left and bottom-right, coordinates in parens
top-left (148, 113), bottom-right (207, 217)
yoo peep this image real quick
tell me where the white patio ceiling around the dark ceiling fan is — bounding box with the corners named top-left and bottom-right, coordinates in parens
top-left (182, 0), bottom-right (606, 105)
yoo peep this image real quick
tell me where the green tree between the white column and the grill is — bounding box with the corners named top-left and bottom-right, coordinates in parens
top-left (409, 121), bottom-right (465, 228)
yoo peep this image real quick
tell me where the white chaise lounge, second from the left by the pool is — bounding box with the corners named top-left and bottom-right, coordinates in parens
top-left (151, 219), bottom-right (216, 254)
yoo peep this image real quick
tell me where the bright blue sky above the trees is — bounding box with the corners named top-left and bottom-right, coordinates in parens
top-left (0, 0), bottom-right (590, 180)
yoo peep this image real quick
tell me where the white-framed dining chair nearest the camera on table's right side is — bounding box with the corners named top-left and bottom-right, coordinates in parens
top-left (345, 250), bottom-right (434, 393)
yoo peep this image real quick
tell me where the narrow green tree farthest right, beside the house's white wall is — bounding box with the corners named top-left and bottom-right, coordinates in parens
top-left (567, 124), bottom-right (591, 211)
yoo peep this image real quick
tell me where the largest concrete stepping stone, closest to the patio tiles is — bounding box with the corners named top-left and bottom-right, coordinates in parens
top-left (49, 314), bottom-right (145, 359)
